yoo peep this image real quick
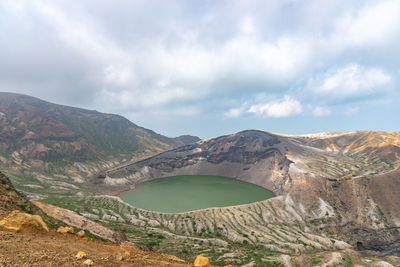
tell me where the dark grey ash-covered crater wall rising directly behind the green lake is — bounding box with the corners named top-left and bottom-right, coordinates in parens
top-left (104, 131), bottom-right (290, 193)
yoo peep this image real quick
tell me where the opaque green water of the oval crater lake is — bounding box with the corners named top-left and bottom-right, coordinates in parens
top-left (120, 176), bottom-right (274, 213)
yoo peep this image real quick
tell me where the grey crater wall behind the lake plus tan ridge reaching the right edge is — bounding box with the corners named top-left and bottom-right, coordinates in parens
top-left (105, 130), bottom-right (400, 191)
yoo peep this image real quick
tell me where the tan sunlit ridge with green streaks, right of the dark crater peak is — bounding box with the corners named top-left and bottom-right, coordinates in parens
top-left (288, 132), bottom-right (400, 179)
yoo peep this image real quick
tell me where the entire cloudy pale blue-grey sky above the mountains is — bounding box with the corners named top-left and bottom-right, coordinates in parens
top-left (0, 0), bottom-right (400, 138)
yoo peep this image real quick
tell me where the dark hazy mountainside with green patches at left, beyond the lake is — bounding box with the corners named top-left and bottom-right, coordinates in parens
top-left (0, 93), bottom-right (199, 199)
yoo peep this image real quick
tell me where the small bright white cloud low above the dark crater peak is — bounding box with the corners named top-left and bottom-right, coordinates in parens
top-left (247, 96), bottom-right (303, 118)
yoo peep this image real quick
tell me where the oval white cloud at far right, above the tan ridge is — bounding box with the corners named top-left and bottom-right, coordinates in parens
top-left (308, 64), bottom-right (391, 99)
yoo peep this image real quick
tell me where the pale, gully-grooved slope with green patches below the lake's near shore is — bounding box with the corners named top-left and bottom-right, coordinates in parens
top-left (46, 196), bottom-right (400, 267)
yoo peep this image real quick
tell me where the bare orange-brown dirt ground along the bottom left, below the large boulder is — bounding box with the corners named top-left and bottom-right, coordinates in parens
top-left (0, 231), bottom-right (192, 267)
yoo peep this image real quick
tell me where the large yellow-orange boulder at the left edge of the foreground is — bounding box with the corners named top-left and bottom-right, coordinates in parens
top-left (0, 210), bottom-right (49, 232)
